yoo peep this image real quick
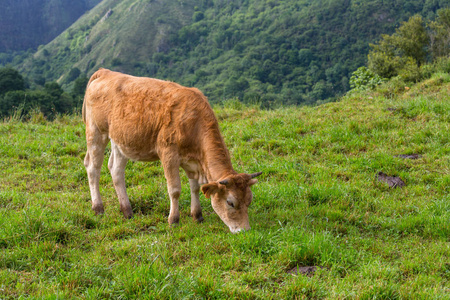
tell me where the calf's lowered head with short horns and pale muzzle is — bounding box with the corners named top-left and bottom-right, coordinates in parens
top-left (202, 172), bottom-right (261, 233)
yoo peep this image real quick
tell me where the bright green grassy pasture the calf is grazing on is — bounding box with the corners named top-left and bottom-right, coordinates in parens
top-left (0, 74), bottom-right (450, 299)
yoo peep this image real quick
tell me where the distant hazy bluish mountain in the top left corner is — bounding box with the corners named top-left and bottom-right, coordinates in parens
top-left (0, 0), bottom-right (101, 52)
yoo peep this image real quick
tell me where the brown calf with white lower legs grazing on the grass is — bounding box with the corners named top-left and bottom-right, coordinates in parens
top-left (83, 69), bottom-right (261, 232)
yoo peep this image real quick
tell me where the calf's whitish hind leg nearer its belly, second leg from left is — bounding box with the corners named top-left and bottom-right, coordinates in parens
top-left (108, 141), bottom-right (133, 219)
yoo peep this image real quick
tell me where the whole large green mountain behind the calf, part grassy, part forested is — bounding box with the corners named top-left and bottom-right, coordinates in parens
top-left (4, 0), bottom-right (448, 106)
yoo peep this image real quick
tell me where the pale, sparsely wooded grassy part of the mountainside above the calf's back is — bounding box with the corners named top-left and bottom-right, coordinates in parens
top-left (20, 0), bottom-right (196, 83)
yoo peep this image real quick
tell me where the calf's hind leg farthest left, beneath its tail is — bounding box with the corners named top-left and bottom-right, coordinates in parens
top-left (84, 127), bottom-right (109, 215)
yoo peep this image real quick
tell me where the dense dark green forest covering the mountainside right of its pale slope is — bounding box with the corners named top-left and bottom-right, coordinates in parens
top-left (155, 1), bottom-right (446, 104)
